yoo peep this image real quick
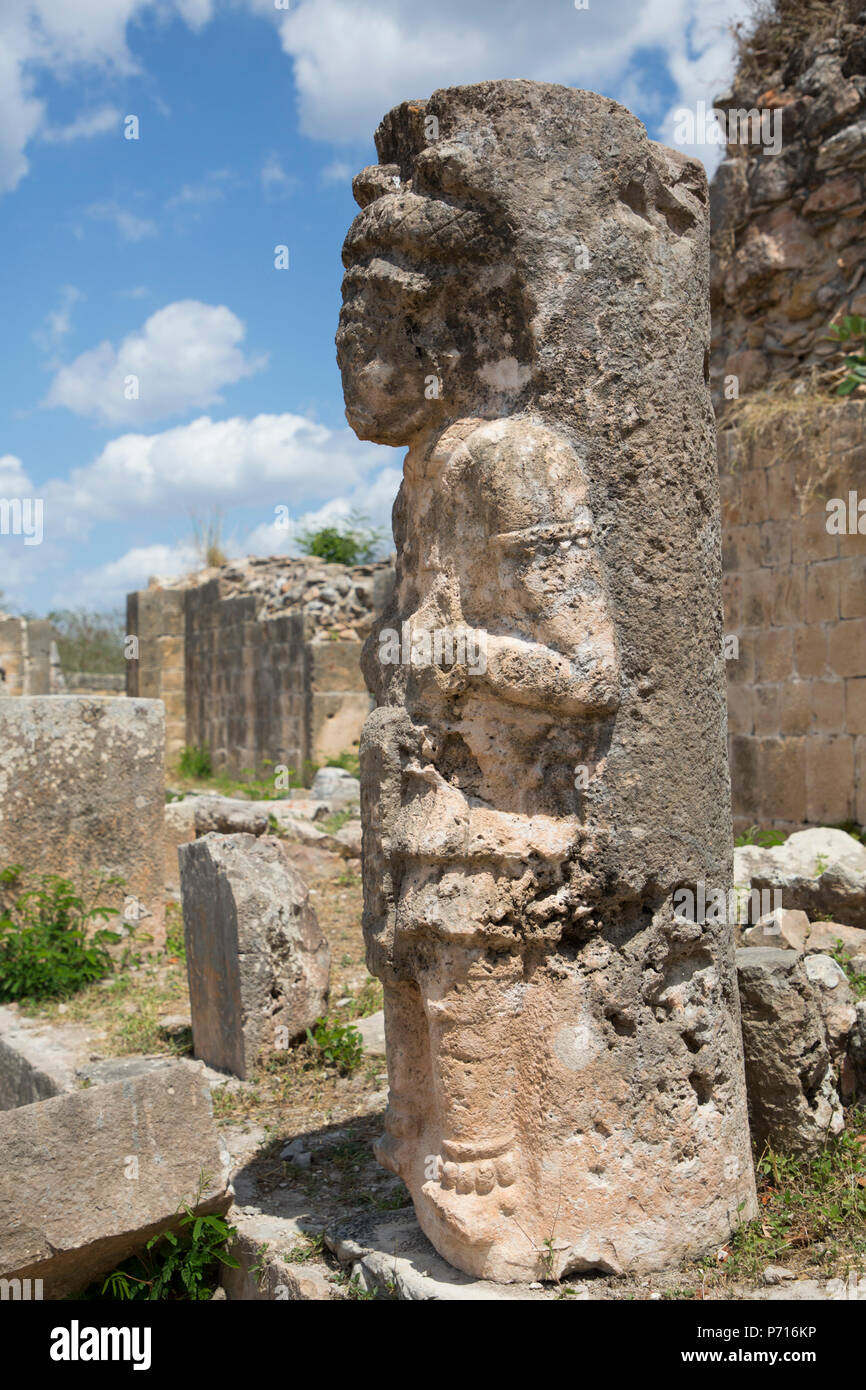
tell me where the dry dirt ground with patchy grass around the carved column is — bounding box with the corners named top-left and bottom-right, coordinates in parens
top-left (16, 844), bottom-right (866, 1300)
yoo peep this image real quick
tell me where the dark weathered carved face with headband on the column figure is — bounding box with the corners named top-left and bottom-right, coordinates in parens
top-left (336, 146), bottom-right (531, 445)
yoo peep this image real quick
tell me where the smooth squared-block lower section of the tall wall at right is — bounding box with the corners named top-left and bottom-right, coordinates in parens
top-left (719, 398), bottom-right (866, 830)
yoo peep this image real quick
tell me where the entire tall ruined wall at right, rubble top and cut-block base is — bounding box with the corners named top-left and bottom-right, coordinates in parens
top-left (710, 10), bottom-right (866, 831)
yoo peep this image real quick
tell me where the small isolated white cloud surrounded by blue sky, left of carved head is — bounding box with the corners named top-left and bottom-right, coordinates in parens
top-left (44, 299), bottom-right (267, 424)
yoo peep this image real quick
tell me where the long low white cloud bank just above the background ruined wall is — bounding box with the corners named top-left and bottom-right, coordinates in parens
top-left (32, 414), bottom-right (402, 607)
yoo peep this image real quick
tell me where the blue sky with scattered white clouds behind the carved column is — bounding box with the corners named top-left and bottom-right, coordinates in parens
top-left (0, 0), bottom-right (746, 613)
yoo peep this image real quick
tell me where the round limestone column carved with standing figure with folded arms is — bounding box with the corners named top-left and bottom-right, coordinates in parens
top-left (338, 82), bottom-right (755, 1280)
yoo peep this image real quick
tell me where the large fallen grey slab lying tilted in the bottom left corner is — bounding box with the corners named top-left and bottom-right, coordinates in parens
top-left (0, 1063), bottom-right (232, 1298)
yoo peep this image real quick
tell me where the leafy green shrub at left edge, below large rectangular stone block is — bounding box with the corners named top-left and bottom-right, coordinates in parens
top-left (0, 865), bottom-right (126, 1001)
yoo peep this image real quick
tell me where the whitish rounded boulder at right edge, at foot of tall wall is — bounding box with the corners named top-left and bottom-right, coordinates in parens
top-left (734, 828), bottom-right (866, 929)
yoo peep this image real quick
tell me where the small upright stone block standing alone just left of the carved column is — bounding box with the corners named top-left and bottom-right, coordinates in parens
top-left (178, 834), bottom-right (331, 1079)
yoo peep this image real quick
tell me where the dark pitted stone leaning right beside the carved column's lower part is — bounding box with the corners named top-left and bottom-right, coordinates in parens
top-left (737, 947), bottom-right (844, 1154)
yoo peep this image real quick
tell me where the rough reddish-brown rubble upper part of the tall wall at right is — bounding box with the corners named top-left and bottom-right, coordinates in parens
top-left (710, 10), bottom-right (866, 396)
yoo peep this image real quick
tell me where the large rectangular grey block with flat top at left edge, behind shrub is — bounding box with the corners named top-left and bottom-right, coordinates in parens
top-left (0, 695), bottom-right (165, 942)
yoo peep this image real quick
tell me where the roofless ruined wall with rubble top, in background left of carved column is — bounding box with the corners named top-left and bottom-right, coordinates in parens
top-left (126, 556), bottom-right (393, 774)
